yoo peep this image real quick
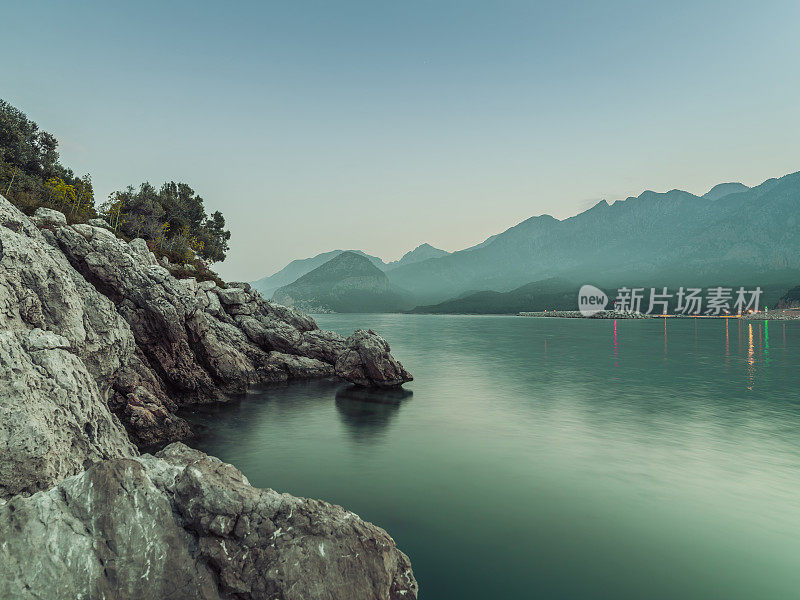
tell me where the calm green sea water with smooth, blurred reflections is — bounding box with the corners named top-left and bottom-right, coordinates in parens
top-left (184, 315), bottom-right (800, 600)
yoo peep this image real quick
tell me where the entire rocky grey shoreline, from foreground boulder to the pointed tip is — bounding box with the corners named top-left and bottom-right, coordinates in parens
top-left (0, 196), bottom-right (417, 600)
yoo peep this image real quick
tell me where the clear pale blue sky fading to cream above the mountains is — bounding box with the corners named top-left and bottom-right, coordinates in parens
top-left (0, 0), bottom-right (800, 281)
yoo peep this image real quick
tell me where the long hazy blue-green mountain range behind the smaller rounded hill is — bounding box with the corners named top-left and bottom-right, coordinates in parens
top-left (254, 168), bottom-right (800, 312)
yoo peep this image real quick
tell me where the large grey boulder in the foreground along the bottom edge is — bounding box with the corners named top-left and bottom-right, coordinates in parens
top-left (0, 444), bottom-right (417, 600)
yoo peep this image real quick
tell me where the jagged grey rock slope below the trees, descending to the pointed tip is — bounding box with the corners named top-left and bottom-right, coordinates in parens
top-left (0, 192), bottom-right (408, 445)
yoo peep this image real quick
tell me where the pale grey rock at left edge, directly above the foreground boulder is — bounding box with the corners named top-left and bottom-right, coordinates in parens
top-left (0, 329), bottom-right (136, 500)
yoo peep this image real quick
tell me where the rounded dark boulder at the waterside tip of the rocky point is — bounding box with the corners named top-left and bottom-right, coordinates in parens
top-left (336, 329), bottom-right (414, 388)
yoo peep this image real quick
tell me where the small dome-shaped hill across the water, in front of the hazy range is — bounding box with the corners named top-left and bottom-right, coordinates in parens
top-left (272, 251), bottom-right (415, 312)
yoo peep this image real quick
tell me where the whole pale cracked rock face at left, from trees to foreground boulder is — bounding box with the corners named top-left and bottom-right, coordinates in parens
top-left (0, 197), bottom-right (136, 498)
